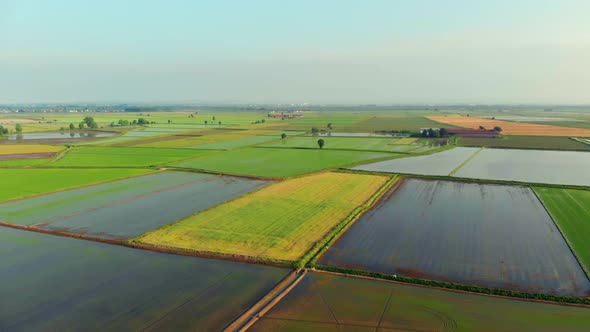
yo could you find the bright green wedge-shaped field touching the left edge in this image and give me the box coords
[0,168,151,201]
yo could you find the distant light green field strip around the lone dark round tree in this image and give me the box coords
[262,137,428,152]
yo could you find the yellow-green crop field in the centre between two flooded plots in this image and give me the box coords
[136,173,389,261]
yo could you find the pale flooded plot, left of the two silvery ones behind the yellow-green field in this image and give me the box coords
[352,148,479,175]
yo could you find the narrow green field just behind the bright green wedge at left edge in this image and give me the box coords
[52,147,212,167]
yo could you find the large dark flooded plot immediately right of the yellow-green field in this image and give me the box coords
[319,179,590,296]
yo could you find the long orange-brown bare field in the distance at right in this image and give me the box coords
[428,116,590,137]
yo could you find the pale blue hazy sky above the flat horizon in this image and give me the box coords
[0,0,590,105]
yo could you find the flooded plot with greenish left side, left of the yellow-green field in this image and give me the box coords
[0,172,269,239]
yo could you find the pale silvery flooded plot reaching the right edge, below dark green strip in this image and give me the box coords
[455,149,590,186]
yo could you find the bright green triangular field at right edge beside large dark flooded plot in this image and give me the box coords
[535,187,590,273]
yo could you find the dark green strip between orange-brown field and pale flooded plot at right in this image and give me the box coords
[457,136,590,151]
